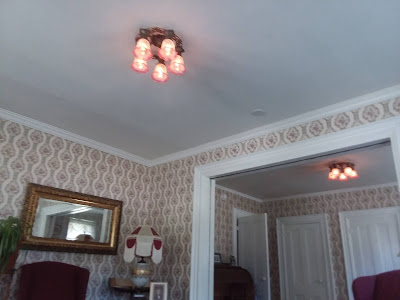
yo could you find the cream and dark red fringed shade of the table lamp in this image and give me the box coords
[124,225,162,264]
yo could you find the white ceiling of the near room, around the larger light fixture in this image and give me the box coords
[0,0,400,159]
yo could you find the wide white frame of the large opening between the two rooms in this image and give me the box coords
[190,117,400,300]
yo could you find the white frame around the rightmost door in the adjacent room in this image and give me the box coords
[339,206,400,300]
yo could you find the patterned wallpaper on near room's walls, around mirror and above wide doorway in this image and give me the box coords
[0,98,400,300]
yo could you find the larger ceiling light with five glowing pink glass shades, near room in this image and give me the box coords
[131,27,186,83]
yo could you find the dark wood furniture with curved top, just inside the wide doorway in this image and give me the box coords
[214,264,254,300]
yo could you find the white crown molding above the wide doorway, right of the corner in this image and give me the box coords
[150,85,400,166]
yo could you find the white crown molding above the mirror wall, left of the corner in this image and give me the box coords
[0,108,150,166]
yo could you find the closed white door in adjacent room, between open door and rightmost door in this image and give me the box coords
[277,214,336,300]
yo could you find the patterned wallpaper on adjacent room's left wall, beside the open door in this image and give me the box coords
[214,188,265,262]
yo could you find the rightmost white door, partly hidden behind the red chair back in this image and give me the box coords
[339,207,400,299]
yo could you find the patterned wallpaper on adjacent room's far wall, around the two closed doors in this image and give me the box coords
[265,185,400,300]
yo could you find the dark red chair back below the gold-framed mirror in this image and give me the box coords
[18,261,89,300]
